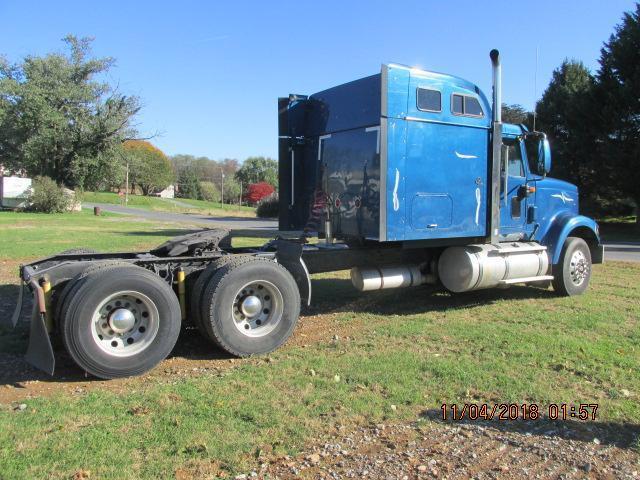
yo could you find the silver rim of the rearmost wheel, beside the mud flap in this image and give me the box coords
[91,290,160,357]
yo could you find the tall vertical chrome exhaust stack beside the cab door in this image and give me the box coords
[486,49,502,244]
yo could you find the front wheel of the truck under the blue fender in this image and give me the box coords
[553,237,592,296]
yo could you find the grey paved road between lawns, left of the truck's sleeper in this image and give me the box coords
[82,203,278,231]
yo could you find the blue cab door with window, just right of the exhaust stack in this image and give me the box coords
[500,138,528,240]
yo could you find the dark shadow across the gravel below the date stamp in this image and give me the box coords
[420,406,640,450]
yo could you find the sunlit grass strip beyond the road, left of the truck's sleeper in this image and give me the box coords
[82,192,256,217]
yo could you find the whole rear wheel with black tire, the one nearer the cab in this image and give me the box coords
[202,257,300,357]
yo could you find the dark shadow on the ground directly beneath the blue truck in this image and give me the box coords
[0,278,554,388]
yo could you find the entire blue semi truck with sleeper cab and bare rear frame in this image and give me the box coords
[13,50,603,378]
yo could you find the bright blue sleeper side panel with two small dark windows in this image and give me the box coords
[404,71,490,240]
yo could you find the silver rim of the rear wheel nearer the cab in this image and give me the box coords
[231,280,284,337]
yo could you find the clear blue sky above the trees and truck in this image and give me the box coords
[0,0,635,160]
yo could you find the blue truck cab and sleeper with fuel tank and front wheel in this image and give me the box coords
[279,51,603,294]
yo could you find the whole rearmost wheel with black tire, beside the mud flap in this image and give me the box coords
[60,265,181,379]
